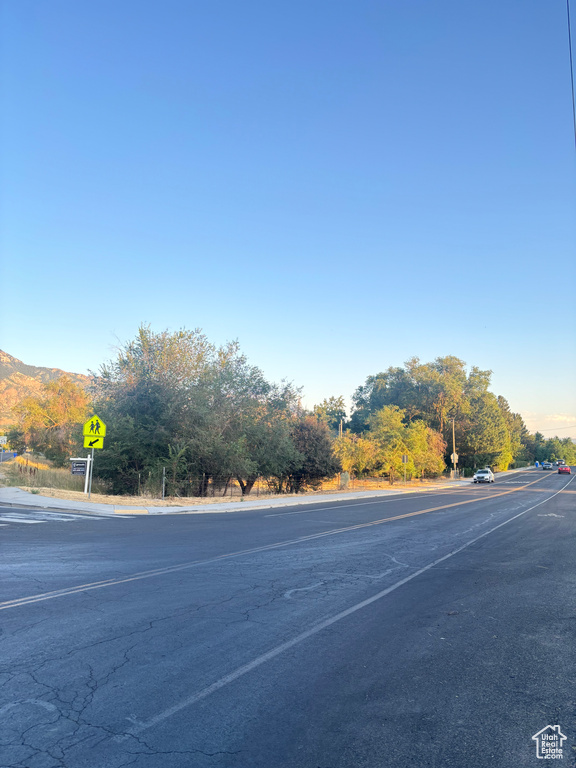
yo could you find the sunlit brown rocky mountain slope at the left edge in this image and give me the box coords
[0,349,91,433]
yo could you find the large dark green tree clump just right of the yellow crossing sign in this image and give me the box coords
[91,326,300,496]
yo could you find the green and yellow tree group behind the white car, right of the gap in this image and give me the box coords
[316,356,576,477]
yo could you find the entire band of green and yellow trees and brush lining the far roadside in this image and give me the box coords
[8,326,576,498]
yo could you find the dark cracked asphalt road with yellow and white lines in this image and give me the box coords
[0,471,576,768]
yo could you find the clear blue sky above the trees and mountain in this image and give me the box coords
[0,0,576,437]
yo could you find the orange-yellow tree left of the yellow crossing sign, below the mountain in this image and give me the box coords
[11,376,90,466]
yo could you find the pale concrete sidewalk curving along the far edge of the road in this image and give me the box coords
[0,467,533,516]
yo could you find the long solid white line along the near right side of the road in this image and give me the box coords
[124,476,576,741]
